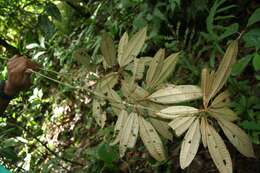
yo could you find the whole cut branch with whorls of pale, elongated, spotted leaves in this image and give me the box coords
[88,27,254,173]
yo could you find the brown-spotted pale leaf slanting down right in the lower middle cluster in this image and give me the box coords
[139,116,166,161]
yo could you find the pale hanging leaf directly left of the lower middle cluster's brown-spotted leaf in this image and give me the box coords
[119,112,139,157]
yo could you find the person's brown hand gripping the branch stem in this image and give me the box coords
[4,55,39,96]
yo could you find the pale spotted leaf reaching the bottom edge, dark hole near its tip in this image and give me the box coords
[207,125,232,173]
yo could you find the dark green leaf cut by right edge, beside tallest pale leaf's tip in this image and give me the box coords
[243,28,260,49]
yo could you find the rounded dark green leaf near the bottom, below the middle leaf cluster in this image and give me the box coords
[97,143,119,164]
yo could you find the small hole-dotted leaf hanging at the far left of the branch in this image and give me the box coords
[92,99,107,128]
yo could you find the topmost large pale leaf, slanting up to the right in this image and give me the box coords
[118,27,147,67]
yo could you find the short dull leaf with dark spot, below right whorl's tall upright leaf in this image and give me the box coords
[210,91,230,108]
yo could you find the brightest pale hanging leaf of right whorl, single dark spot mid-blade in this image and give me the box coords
[180,119,201,169]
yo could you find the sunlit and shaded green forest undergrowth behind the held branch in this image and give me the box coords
[0,0,260,173]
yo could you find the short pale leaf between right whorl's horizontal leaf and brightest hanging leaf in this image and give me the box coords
[168,116,196,136]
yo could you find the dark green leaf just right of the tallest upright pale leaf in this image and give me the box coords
[231,55,252,76]
